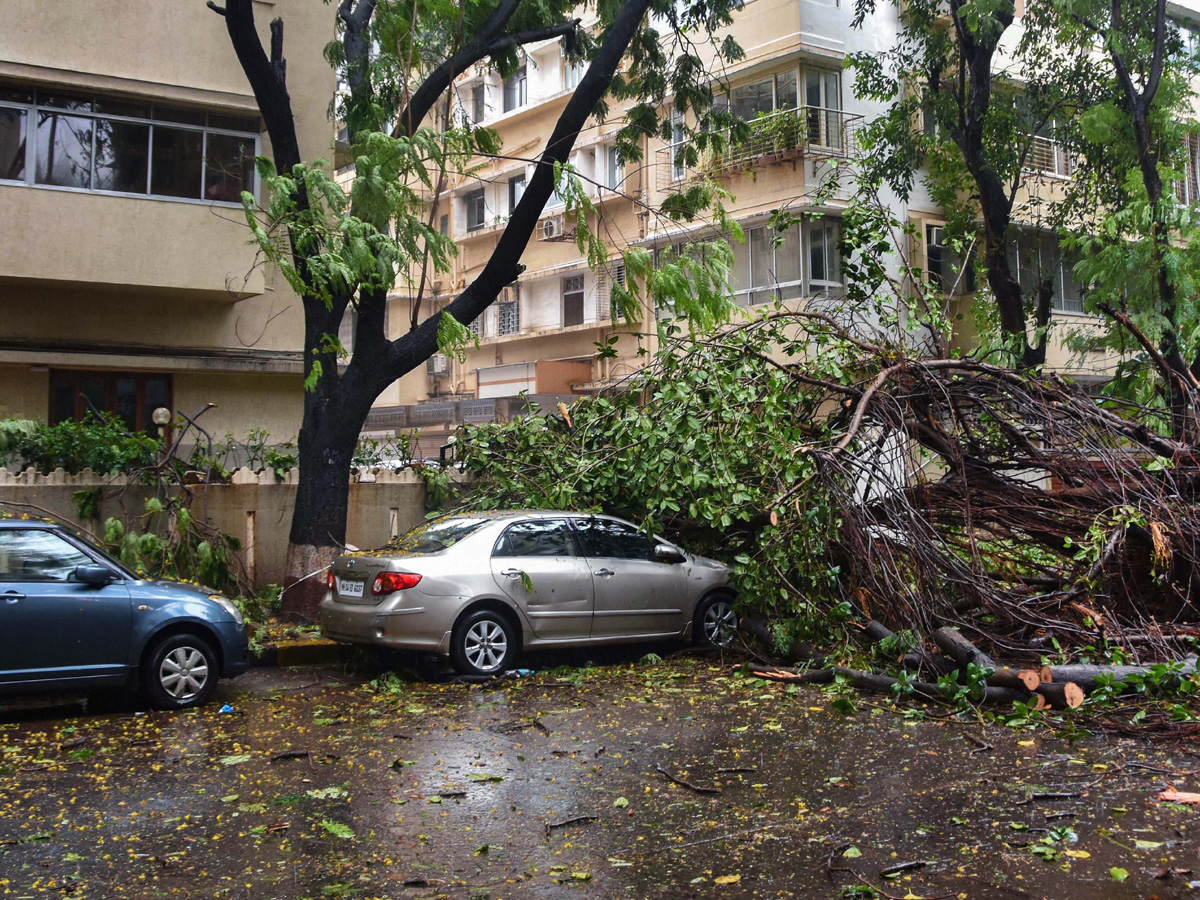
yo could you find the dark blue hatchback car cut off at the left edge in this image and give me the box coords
[0,512,250,709]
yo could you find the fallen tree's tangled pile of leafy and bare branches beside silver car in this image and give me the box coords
[464,307,1200,696]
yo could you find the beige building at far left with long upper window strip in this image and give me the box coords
[0,0,335,440]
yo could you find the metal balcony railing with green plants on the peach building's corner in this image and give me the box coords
[655,107,864,191]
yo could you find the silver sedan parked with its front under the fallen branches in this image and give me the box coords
[320,511,737,674]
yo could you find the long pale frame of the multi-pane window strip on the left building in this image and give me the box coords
[0,85,263,209]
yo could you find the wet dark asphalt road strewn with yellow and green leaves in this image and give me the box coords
[0,652,1200,900]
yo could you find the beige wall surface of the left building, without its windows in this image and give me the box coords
[0,0,336,439]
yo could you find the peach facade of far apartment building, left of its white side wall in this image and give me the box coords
[367,0,899,455]
